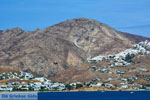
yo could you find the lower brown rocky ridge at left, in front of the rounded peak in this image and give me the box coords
[0,28,86,77]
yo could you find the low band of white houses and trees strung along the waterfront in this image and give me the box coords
[0,72,150,91]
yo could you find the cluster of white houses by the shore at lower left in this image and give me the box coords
[0,72,65,91]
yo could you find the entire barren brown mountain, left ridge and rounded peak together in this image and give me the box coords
[0,18,150,81]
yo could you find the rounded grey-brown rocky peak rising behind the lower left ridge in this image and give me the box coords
[44,18,148,56]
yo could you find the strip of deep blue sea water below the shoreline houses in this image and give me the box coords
[38,91,150,100]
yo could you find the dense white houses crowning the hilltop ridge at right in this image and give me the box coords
[88,40,150,66]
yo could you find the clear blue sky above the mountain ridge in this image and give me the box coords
[0,0,150,37]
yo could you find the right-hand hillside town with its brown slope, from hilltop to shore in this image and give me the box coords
[85,40,150,90]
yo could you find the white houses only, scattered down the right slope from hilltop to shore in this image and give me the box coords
[88,41,150,90]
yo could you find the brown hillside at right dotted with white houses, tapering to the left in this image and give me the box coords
[52,41,150,88]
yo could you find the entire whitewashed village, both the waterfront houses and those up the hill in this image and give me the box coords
[0,41,150,91]
